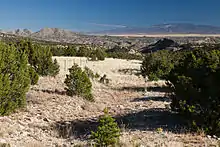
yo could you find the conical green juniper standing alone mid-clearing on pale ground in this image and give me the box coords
[64,64,94,101]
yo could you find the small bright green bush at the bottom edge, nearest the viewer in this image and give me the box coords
[90,109,120,147]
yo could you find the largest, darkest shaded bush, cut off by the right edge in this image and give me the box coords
[167,49,220,135]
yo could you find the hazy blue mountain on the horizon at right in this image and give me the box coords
[92,23,220,35]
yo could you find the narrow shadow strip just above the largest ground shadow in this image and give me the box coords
[131,96,171,102]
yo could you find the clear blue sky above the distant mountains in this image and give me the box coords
[0,0,220,32]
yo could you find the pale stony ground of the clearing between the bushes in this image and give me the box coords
[0,59,220,147]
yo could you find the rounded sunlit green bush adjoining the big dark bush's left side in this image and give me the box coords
[141,50,174,81]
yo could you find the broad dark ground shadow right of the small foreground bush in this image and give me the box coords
[116,108,187,133]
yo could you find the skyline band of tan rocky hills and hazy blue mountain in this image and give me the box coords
[0,23,220,39]
